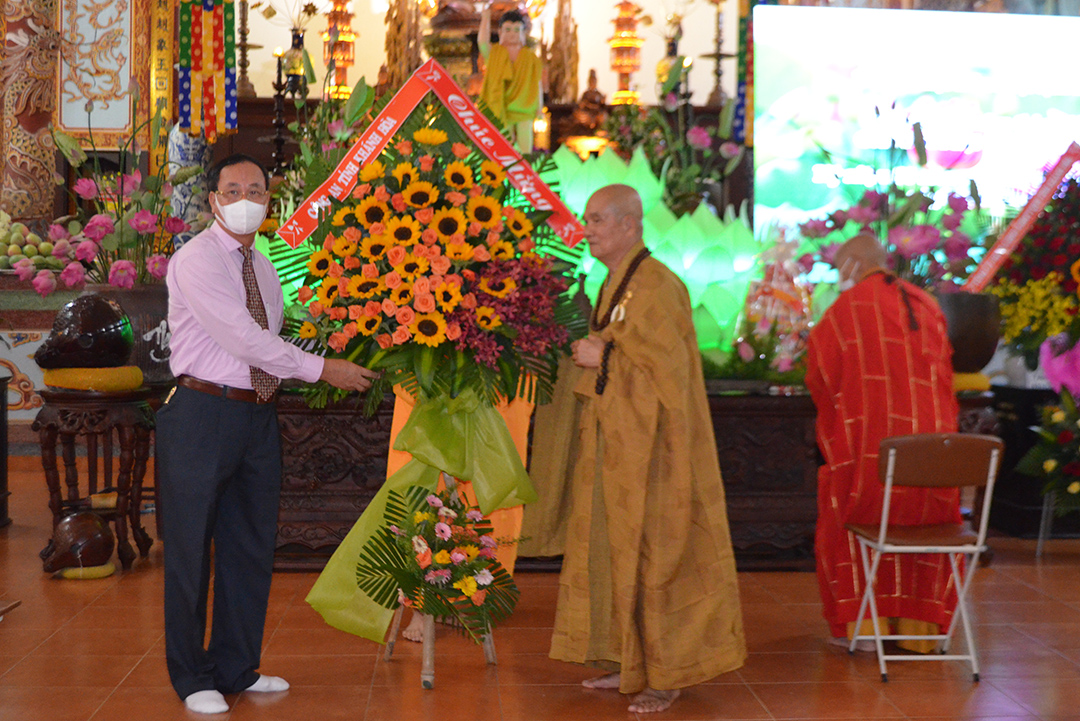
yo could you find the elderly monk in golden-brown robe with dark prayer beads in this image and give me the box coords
[551,186,746,713]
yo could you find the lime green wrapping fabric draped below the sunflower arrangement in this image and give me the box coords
[307,391,537,643]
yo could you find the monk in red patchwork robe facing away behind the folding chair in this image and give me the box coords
[806,234,960,651]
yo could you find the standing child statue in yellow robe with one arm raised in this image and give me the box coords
[476,5,543,153]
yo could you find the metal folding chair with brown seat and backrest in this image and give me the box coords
[847,433,1004,682]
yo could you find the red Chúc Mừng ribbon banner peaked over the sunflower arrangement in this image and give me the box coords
[278,59,584,248]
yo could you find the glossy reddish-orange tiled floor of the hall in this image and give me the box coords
[0,458,1080,721]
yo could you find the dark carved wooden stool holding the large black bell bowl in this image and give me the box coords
[30,386,156,570]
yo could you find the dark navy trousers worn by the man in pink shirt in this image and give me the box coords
[156,387,281,698]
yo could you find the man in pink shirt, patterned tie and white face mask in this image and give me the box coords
[157,155,375,713]
